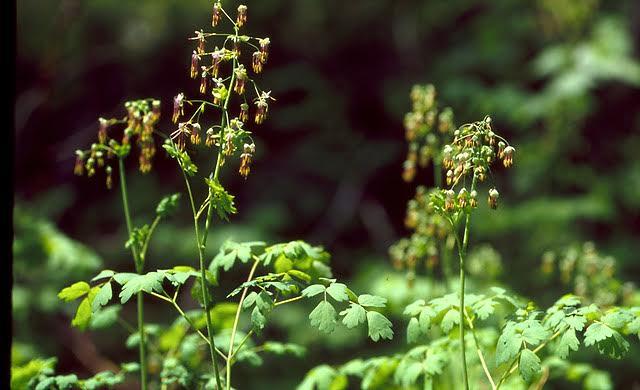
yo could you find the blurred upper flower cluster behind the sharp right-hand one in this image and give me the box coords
[402,84,454,182]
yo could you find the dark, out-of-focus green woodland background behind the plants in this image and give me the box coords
[12,0,640,388]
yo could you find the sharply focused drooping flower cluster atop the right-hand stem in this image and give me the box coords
[431,116,515,214]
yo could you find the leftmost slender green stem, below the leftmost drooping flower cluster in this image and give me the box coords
[118,157,147,390]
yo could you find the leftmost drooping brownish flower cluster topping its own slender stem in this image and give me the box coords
[73,99,160,188]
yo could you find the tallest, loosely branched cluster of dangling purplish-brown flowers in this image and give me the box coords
[170,1,275,178]
